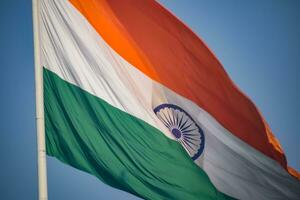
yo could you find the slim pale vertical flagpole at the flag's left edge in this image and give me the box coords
[32,0,48,200]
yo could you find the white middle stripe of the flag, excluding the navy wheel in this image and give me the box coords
[40,0,300,199]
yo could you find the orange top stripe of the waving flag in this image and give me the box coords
[71,0,298,178]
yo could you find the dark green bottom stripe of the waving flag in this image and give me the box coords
[44,68,233,200]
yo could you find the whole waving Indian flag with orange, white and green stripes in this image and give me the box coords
[38,0,300,200]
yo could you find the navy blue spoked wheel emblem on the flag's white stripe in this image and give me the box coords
[154,104,205,160]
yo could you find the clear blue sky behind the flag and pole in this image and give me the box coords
[0,0,300,200]
